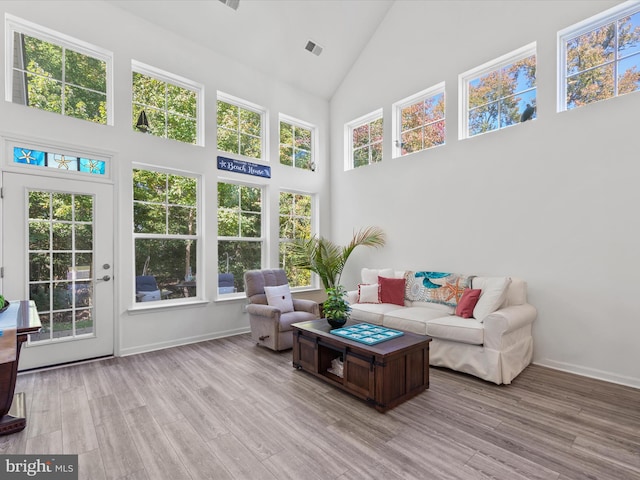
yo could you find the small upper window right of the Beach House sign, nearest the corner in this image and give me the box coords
[280,114,317,171]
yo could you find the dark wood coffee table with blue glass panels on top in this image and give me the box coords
[292,319,431,412]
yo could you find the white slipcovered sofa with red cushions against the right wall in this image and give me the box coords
[347,268,537,384]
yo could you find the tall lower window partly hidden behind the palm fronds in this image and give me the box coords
[279,192,313,287]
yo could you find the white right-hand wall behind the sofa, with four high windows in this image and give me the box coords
[331,0,640,387]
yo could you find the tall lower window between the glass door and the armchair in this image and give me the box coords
[133,169,199,302]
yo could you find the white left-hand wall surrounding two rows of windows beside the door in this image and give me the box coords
[0,1,329,354]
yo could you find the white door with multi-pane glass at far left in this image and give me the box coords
[2,172,114,370]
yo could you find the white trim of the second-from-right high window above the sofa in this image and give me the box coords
[458,42,538,140]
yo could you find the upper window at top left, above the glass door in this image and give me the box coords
[5,14,113,125]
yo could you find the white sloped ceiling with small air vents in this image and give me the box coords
[106,0,395,99]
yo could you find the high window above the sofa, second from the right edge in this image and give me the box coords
[458,42,537,139]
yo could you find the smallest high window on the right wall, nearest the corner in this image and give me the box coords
[345,108,384,170]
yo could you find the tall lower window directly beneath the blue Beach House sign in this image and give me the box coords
[218,182,264,293]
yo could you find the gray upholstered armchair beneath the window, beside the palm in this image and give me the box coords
[244,270,320,351]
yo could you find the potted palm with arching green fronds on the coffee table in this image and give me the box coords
[293,227,386,327]
